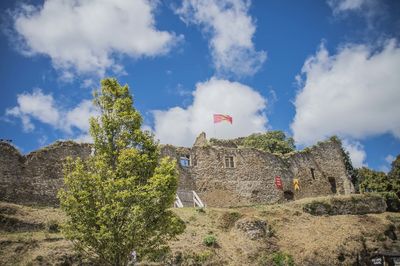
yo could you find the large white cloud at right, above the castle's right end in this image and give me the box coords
[291,40,400,144]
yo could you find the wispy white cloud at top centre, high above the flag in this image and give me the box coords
[176,0,267,76]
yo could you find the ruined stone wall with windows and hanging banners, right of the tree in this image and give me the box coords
[162,138,351,207]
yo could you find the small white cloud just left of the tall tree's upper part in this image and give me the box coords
[6,89,98,135]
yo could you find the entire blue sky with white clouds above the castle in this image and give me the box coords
[0,0,400,171]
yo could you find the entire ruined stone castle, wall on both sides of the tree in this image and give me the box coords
[0,133,354,207]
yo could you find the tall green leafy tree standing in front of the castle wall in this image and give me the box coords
[59,79,184,265]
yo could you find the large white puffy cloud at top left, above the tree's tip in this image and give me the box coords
[13,0,181,77]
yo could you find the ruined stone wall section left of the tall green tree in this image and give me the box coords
[0,141,90,206]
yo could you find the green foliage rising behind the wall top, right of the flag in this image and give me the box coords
[243,130,296,154]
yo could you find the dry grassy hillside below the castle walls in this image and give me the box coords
[0,194,400,265]
